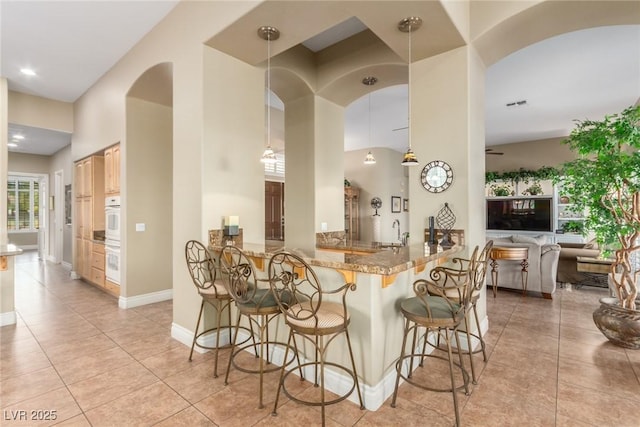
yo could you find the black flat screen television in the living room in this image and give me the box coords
[487,198,553,231]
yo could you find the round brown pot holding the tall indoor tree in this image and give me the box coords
[593,298,640,350]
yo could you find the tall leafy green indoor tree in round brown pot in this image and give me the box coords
[561,106,640,348]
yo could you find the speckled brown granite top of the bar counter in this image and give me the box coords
[210,242,464,275]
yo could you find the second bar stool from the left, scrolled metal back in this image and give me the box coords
[220,246,291,409]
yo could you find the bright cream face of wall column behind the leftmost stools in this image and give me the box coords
[204,48,265,244]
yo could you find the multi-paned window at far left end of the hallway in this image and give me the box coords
[7,175,40,231]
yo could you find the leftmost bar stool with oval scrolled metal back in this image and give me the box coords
[184,240,233,378]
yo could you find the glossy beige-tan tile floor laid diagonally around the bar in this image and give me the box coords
[0,253,640,426]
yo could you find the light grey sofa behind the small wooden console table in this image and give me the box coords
[487,235,560,299]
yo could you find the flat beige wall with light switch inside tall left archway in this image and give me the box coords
[121,97,173,297]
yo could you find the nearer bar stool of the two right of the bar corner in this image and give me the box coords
[391,258,477,426]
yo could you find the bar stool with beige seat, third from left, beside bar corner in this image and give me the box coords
[269,252,364,426]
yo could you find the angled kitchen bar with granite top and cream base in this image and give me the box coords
[209,234,464,410]
